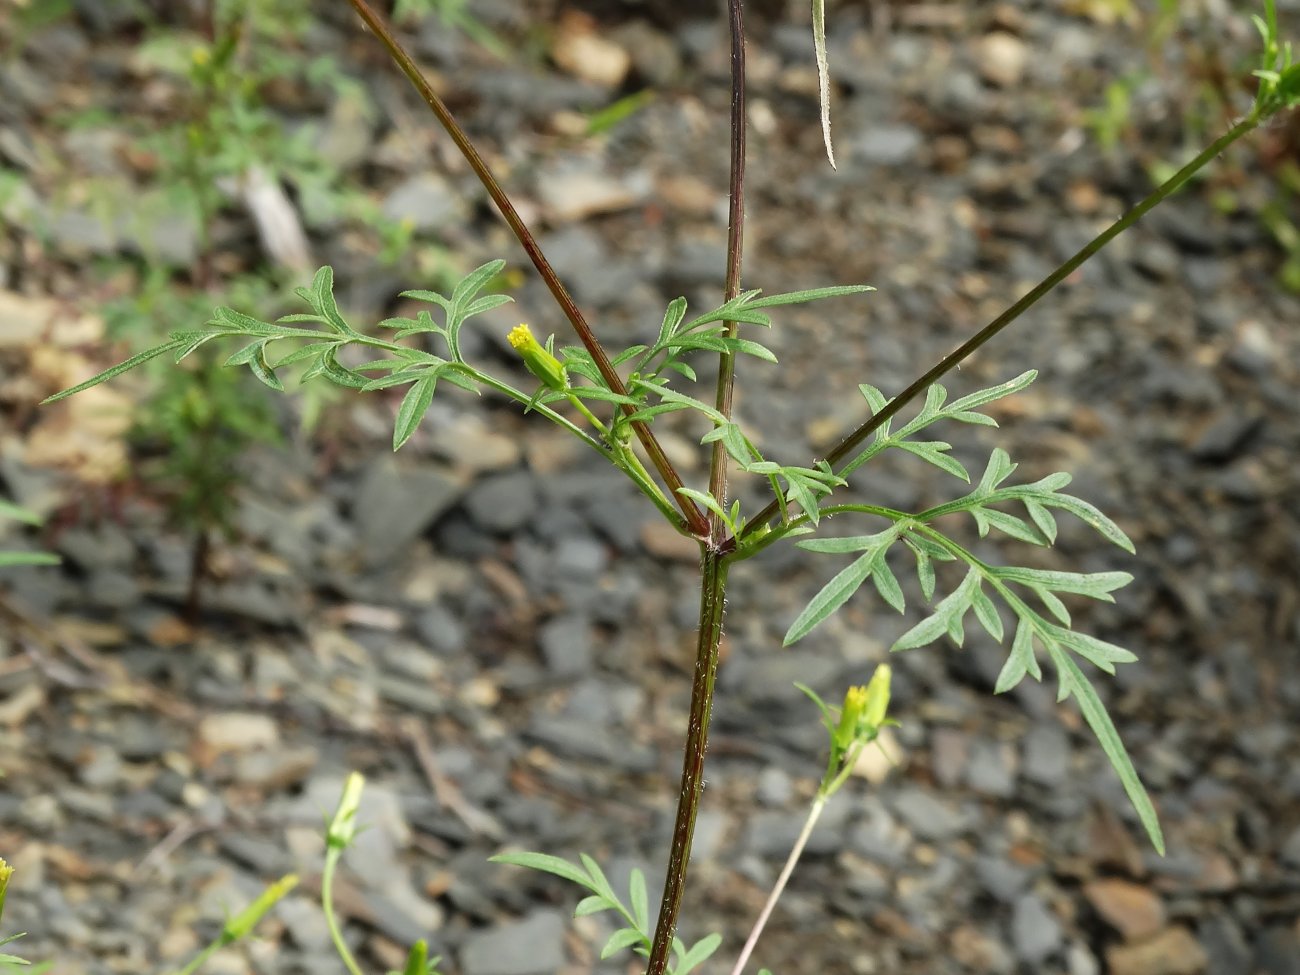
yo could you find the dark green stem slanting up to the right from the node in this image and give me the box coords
[724,111,1264,551]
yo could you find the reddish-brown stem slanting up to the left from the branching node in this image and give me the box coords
[348,0,709,538]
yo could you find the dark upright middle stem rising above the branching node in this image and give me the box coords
[709,0,745,540]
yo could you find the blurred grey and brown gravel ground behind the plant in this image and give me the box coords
[0,0,1300,975]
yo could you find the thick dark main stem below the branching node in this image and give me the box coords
[646,546,728,975]
